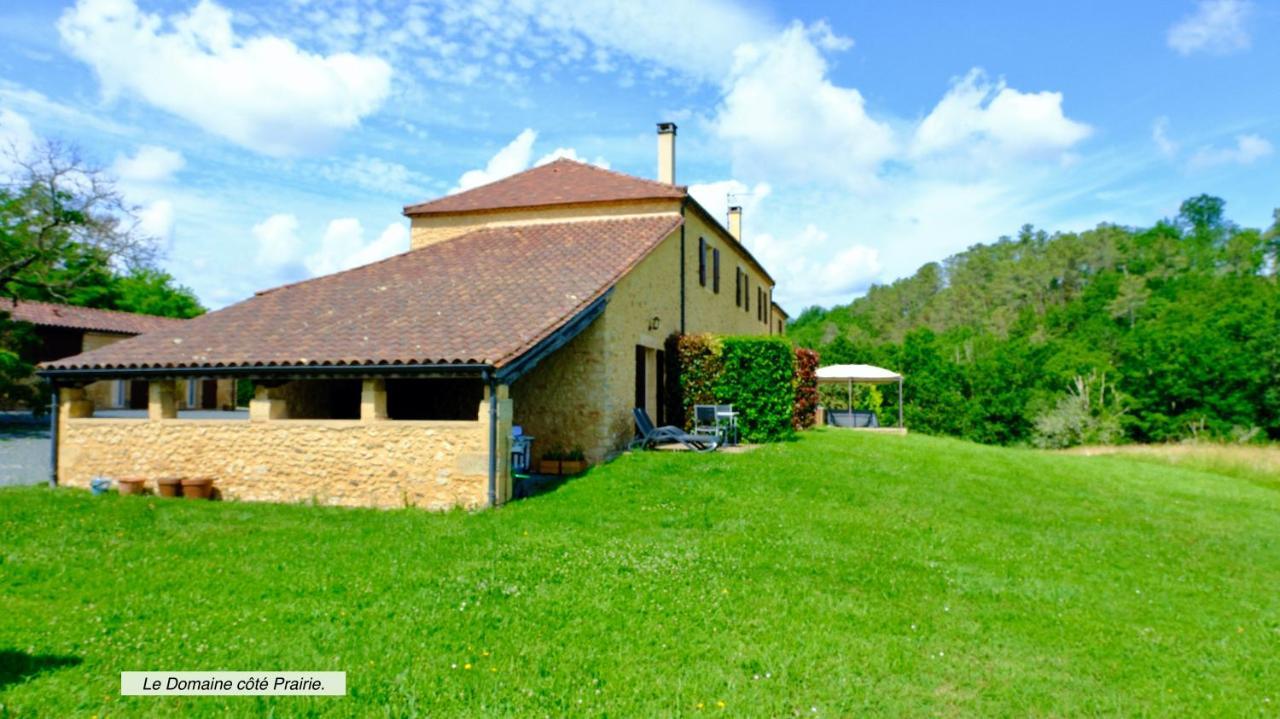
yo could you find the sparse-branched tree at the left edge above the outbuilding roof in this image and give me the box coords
[0,141,156,301]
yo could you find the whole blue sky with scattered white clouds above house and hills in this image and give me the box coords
[0,0,1280,311]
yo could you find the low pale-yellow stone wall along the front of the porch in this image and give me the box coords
[58,412,489,509]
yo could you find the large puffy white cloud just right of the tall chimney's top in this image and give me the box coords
[712,23,896,186]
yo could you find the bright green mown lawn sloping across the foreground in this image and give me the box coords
[0,431,1280,716]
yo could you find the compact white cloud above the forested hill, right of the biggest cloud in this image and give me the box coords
[910,68,1092,161]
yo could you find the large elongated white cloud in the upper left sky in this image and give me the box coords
[58,0,392,155]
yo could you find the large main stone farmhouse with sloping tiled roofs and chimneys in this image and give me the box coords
[42,123,785,509]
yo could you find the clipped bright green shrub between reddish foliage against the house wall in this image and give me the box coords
[716,336,796,441]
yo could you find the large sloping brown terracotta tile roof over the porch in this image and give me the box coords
[42,214,681,370]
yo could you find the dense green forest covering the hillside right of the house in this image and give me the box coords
[788,194,1280,446]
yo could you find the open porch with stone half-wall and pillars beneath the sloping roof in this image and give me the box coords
[47,367,512,509]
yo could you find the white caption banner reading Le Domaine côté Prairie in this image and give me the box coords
[120,672,347,696]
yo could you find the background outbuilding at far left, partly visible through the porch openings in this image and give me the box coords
[0,299,236,409]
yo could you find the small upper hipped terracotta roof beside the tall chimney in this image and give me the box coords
[404,159,687,216]
